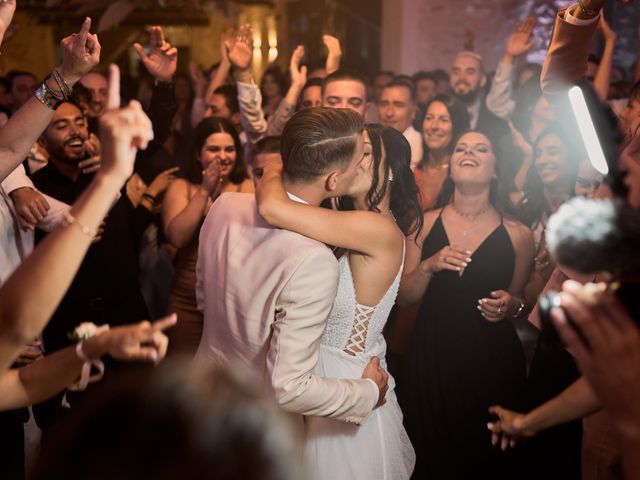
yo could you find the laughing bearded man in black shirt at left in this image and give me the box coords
[33,102,152,440]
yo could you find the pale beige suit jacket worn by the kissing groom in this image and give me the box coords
[196,193,379,424]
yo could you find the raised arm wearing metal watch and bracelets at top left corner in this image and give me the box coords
[0,16,100,181]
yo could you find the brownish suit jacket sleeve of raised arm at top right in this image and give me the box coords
[540,9,598,105]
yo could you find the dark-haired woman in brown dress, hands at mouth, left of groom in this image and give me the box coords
[162,117,253,355]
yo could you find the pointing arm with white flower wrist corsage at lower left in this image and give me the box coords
[0,315,176,411]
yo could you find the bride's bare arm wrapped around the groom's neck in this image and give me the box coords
[256,162,403,256]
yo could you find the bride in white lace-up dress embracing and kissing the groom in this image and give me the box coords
[256,125,422,480]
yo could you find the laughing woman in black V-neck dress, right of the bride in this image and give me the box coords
[398,132,534,479]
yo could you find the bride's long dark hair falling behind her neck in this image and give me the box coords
[338,124,424,236]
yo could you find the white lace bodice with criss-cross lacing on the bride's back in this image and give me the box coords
[321,249,404,356]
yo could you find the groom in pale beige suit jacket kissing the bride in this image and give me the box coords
[196,108,388,424]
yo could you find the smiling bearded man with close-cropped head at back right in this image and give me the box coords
[450,51,509,143]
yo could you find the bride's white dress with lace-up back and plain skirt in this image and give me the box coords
[305,254,415,480]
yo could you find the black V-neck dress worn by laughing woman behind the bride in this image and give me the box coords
[403,217,526,479]
